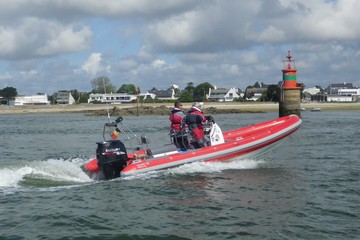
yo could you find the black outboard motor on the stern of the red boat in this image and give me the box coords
[96,140,128,180]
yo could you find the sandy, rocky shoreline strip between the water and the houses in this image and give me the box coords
[0,102,360,115]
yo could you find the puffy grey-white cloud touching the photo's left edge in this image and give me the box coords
[0,18,92,60]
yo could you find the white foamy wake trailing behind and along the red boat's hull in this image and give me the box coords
[0,157,263,193]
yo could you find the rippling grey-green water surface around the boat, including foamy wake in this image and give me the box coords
[0,111,360,240]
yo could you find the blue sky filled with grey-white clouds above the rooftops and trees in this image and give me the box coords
[0,0,360,94]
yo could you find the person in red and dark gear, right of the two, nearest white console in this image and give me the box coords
[183,102,207,148]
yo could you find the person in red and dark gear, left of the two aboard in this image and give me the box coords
[169,102,186,148]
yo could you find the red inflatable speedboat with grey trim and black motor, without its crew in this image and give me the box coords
[85,115,302,179]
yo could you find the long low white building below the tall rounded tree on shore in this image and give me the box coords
[88,93,137,104]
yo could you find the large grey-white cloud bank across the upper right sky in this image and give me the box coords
[148,0,360,52]
